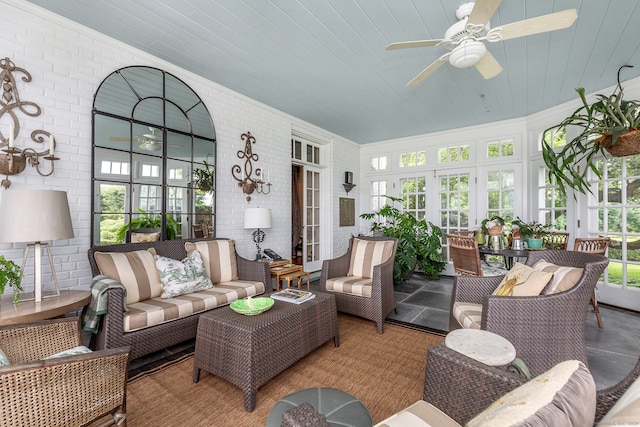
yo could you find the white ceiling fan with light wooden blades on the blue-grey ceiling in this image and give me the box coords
[386,0,578,86]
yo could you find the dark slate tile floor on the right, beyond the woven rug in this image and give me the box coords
[389,273,640,389]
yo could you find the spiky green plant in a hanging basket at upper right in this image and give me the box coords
[542,65,640,195]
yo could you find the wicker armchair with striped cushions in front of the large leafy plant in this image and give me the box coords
[320,236,398,334]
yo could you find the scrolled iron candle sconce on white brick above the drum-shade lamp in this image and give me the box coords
[0,58,60,189]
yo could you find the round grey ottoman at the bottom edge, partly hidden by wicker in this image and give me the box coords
[267,387,373,427]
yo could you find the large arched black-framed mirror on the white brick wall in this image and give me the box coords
[91,66,216,245]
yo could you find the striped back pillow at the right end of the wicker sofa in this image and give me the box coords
[184,240,238,285]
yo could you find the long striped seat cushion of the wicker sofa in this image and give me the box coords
[124,281,264,332]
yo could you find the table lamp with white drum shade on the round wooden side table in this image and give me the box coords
[0,190,74,302]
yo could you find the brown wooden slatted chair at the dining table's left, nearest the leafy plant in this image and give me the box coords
[447,233,507,276]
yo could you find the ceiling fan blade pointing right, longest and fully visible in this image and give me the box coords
[487,9,578,41]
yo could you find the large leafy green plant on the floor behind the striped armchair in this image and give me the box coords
[360,196,446,285]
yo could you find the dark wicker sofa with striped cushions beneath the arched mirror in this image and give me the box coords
[88,238,271,360]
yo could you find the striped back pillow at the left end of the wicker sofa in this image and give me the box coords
[94,251,162,305]
